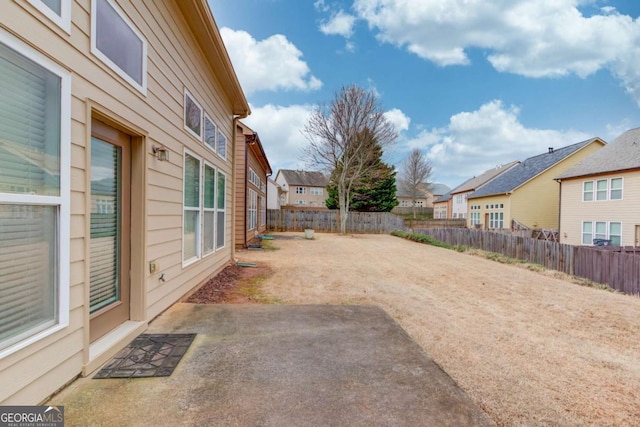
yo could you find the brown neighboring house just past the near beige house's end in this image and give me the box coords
[234,121,272,248]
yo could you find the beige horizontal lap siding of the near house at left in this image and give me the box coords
[0,0,248,404]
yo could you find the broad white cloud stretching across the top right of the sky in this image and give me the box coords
[354,0,640,102]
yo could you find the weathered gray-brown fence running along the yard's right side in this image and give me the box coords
[416,228,640,295]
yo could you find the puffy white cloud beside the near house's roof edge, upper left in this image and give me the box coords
[220,27,322,95]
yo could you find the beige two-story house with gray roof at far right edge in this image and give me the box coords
[557,128,640,246]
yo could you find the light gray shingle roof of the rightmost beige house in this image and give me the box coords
[557,128,640,179]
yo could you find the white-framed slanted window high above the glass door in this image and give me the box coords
[91,0,147,94]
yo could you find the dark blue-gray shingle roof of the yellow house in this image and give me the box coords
[468,138,602,199]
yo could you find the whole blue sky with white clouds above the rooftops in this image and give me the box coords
[209,0,640,187]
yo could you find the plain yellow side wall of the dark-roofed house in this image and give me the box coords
[511,143,602,229]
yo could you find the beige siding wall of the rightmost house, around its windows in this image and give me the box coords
[560,171,640,246]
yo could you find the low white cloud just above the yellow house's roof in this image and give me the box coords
[405,100,597,187]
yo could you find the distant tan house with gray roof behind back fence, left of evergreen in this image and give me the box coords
[275,169,329,208]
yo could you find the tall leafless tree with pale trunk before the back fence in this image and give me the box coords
[302,85,398,234]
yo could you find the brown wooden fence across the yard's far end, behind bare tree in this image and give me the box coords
[267,209,404,234]
